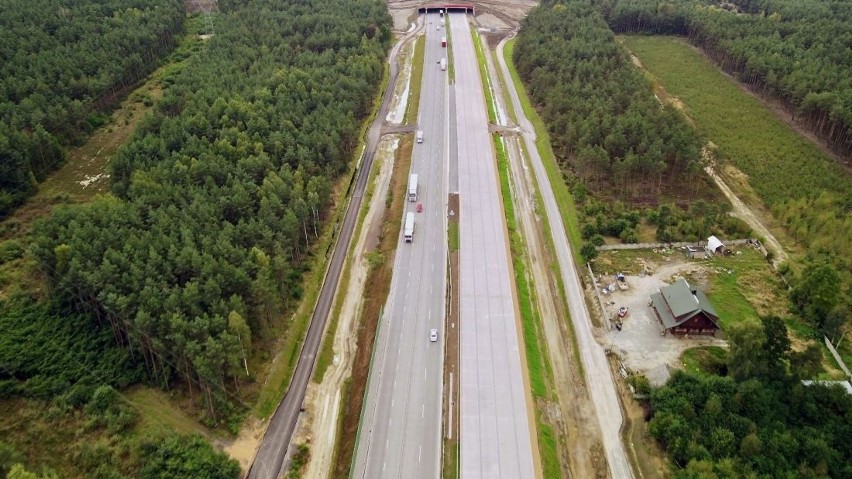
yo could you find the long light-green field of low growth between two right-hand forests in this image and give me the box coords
[624,36,852,266]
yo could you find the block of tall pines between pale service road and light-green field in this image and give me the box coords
[514,1,701,201]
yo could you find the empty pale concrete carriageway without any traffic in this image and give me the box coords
[450,13,535,479]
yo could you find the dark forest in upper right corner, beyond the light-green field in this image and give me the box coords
[593,0,852,161]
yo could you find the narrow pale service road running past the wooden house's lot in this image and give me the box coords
[497,35,633,479]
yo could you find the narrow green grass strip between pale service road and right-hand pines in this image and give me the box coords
[503,40,583,264]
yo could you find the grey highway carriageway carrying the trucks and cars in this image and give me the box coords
[353,14,448,479]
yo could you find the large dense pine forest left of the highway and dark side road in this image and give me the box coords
[31,0,391,422]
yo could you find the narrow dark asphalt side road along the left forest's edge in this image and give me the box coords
[248,17,417,479]
